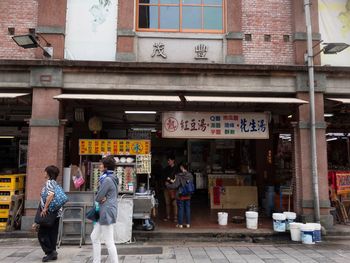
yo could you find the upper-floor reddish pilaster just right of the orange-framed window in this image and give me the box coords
[225,0,244,64]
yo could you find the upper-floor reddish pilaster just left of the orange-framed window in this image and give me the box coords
[116,0,137,61]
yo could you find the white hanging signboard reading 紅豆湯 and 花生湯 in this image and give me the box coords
[162,111,269,139]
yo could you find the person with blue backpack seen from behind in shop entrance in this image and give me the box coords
[166,163,194,228]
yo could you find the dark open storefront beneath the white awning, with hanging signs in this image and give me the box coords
[48,93,305,231]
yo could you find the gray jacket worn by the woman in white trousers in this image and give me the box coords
[95,176,118,225]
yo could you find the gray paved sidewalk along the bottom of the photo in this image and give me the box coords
[0,239,350,263]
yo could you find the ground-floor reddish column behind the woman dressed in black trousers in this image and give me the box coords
[22,88,64,230]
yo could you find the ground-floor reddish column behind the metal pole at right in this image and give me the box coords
[294,92,333,227]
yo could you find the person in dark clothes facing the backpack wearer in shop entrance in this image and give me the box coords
[162,155,180,222]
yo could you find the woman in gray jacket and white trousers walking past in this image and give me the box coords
[91,155,118,263]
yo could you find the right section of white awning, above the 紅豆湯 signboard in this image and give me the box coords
[185,96,309,104]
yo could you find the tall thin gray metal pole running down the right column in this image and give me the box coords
[304,0,320,223]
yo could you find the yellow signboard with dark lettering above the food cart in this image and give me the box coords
[79,139,151,155]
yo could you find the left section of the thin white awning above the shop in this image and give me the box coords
[54,94,181,102]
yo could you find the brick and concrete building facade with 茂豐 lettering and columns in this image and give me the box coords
[0,0,350,229]
